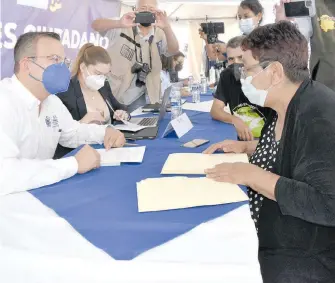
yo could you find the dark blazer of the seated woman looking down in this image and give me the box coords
[54,76,126,159]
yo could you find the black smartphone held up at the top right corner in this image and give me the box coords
[284,0,316,18]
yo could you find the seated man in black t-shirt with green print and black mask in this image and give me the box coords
[211,36,268,141]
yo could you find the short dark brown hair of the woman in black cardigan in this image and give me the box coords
[242,21,309,83]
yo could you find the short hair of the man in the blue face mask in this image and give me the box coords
[14,31,60,73]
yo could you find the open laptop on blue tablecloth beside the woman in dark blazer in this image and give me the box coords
[122,87,172,140]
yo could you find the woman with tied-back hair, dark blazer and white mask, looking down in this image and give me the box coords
[54,43,130,159]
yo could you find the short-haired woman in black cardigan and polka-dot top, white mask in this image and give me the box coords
[206,21,335,283]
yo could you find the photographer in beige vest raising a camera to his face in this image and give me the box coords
[92,0,179,112]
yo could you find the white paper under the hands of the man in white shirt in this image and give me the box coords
[98,146,145,166]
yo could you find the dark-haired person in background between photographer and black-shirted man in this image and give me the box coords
[161,51,189,99]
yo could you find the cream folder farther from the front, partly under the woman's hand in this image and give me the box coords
[161,153,249,174]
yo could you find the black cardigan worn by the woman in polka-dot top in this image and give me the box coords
[258,80,335,283]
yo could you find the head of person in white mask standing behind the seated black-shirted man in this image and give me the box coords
[237,0,264,35]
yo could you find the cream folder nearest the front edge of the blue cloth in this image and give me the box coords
[137,177,248,212]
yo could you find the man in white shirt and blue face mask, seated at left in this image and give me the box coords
[0,32,125,195]
